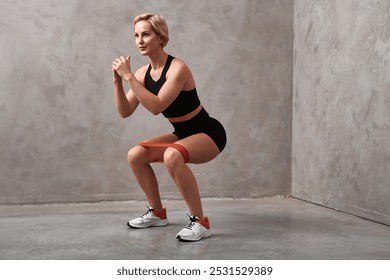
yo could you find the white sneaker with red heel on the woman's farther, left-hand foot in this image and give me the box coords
[127,206,169,228]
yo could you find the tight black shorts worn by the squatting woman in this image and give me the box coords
[172,108,226,152]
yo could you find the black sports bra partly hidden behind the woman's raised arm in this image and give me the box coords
[145,55,200,118]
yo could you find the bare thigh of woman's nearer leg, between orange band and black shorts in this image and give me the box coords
[175,133,220,163]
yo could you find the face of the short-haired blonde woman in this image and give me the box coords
[134,20,161,55]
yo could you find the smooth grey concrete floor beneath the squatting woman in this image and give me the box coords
[0,198,390,260]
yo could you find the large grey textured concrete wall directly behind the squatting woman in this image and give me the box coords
[0,0,292,203]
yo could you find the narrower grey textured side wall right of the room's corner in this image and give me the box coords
[292,0,390,224]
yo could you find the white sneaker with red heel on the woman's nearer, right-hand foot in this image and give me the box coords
[176,216,212,241]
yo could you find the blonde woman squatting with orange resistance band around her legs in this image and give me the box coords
[112,14,226,241]
